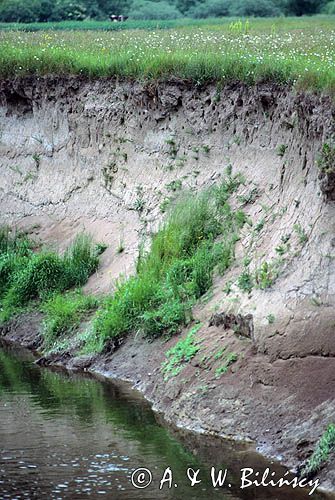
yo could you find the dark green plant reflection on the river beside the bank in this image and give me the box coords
[0,344,205,471]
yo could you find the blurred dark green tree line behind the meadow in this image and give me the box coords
[0,0,335,23]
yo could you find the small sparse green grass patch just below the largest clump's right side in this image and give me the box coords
[162,324,202,380]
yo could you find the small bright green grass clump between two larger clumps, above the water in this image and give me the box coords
[42,290,99,349]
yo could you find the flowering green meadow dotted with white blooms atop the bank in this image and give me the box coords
[0,16,335,93]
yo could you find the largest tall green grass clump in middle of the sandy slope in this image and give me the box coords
[85,171,242,350]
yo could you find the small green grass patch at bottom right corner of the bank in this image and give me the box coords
[299,424,335,478]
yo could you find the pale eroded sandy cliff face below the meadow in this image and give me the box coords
[0,77,335,488]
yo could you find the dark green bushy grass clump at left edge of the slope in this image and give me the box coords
[0,235,99,321]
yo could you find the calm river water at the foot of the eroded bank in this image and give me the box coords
[0,344,330,500]
